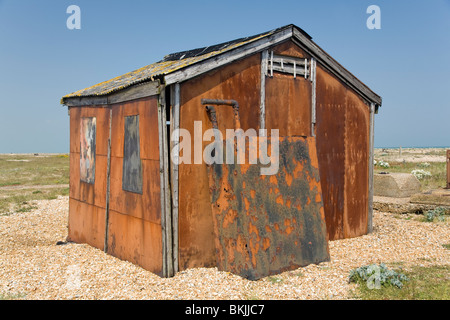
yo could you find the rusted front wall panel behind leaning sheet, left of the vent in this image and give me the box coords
[178,54,261,270]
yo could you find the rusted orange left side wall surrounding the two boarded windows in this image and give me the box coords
[68,97,162,274]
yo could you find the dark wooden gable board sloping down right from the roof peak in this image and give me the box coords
[292,28,381,105]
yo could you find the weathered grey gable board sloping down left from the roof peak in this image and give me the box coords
[165,28,292,85]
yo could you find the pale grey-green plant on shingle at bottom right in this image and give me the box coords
[349,263,408,289]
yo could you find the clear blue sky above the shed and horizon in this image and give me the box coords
[0,0,450,153]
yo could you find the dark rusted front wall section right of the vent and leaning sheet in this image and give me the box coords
[316,64,369,240]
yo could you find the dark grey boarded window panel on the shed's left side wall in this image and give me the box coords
[122,115,142,194]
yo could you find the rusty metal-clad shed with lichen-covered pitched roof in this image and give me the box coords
[61,25,381,278]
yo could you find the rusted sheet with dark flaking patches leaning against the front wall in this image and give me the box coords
[208,137,329,280]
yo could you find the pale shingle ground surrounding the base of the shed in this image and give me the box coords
[0,197,450,300]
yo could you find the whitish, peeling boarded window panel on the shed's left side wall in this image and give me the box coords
[80,117,97,183]
